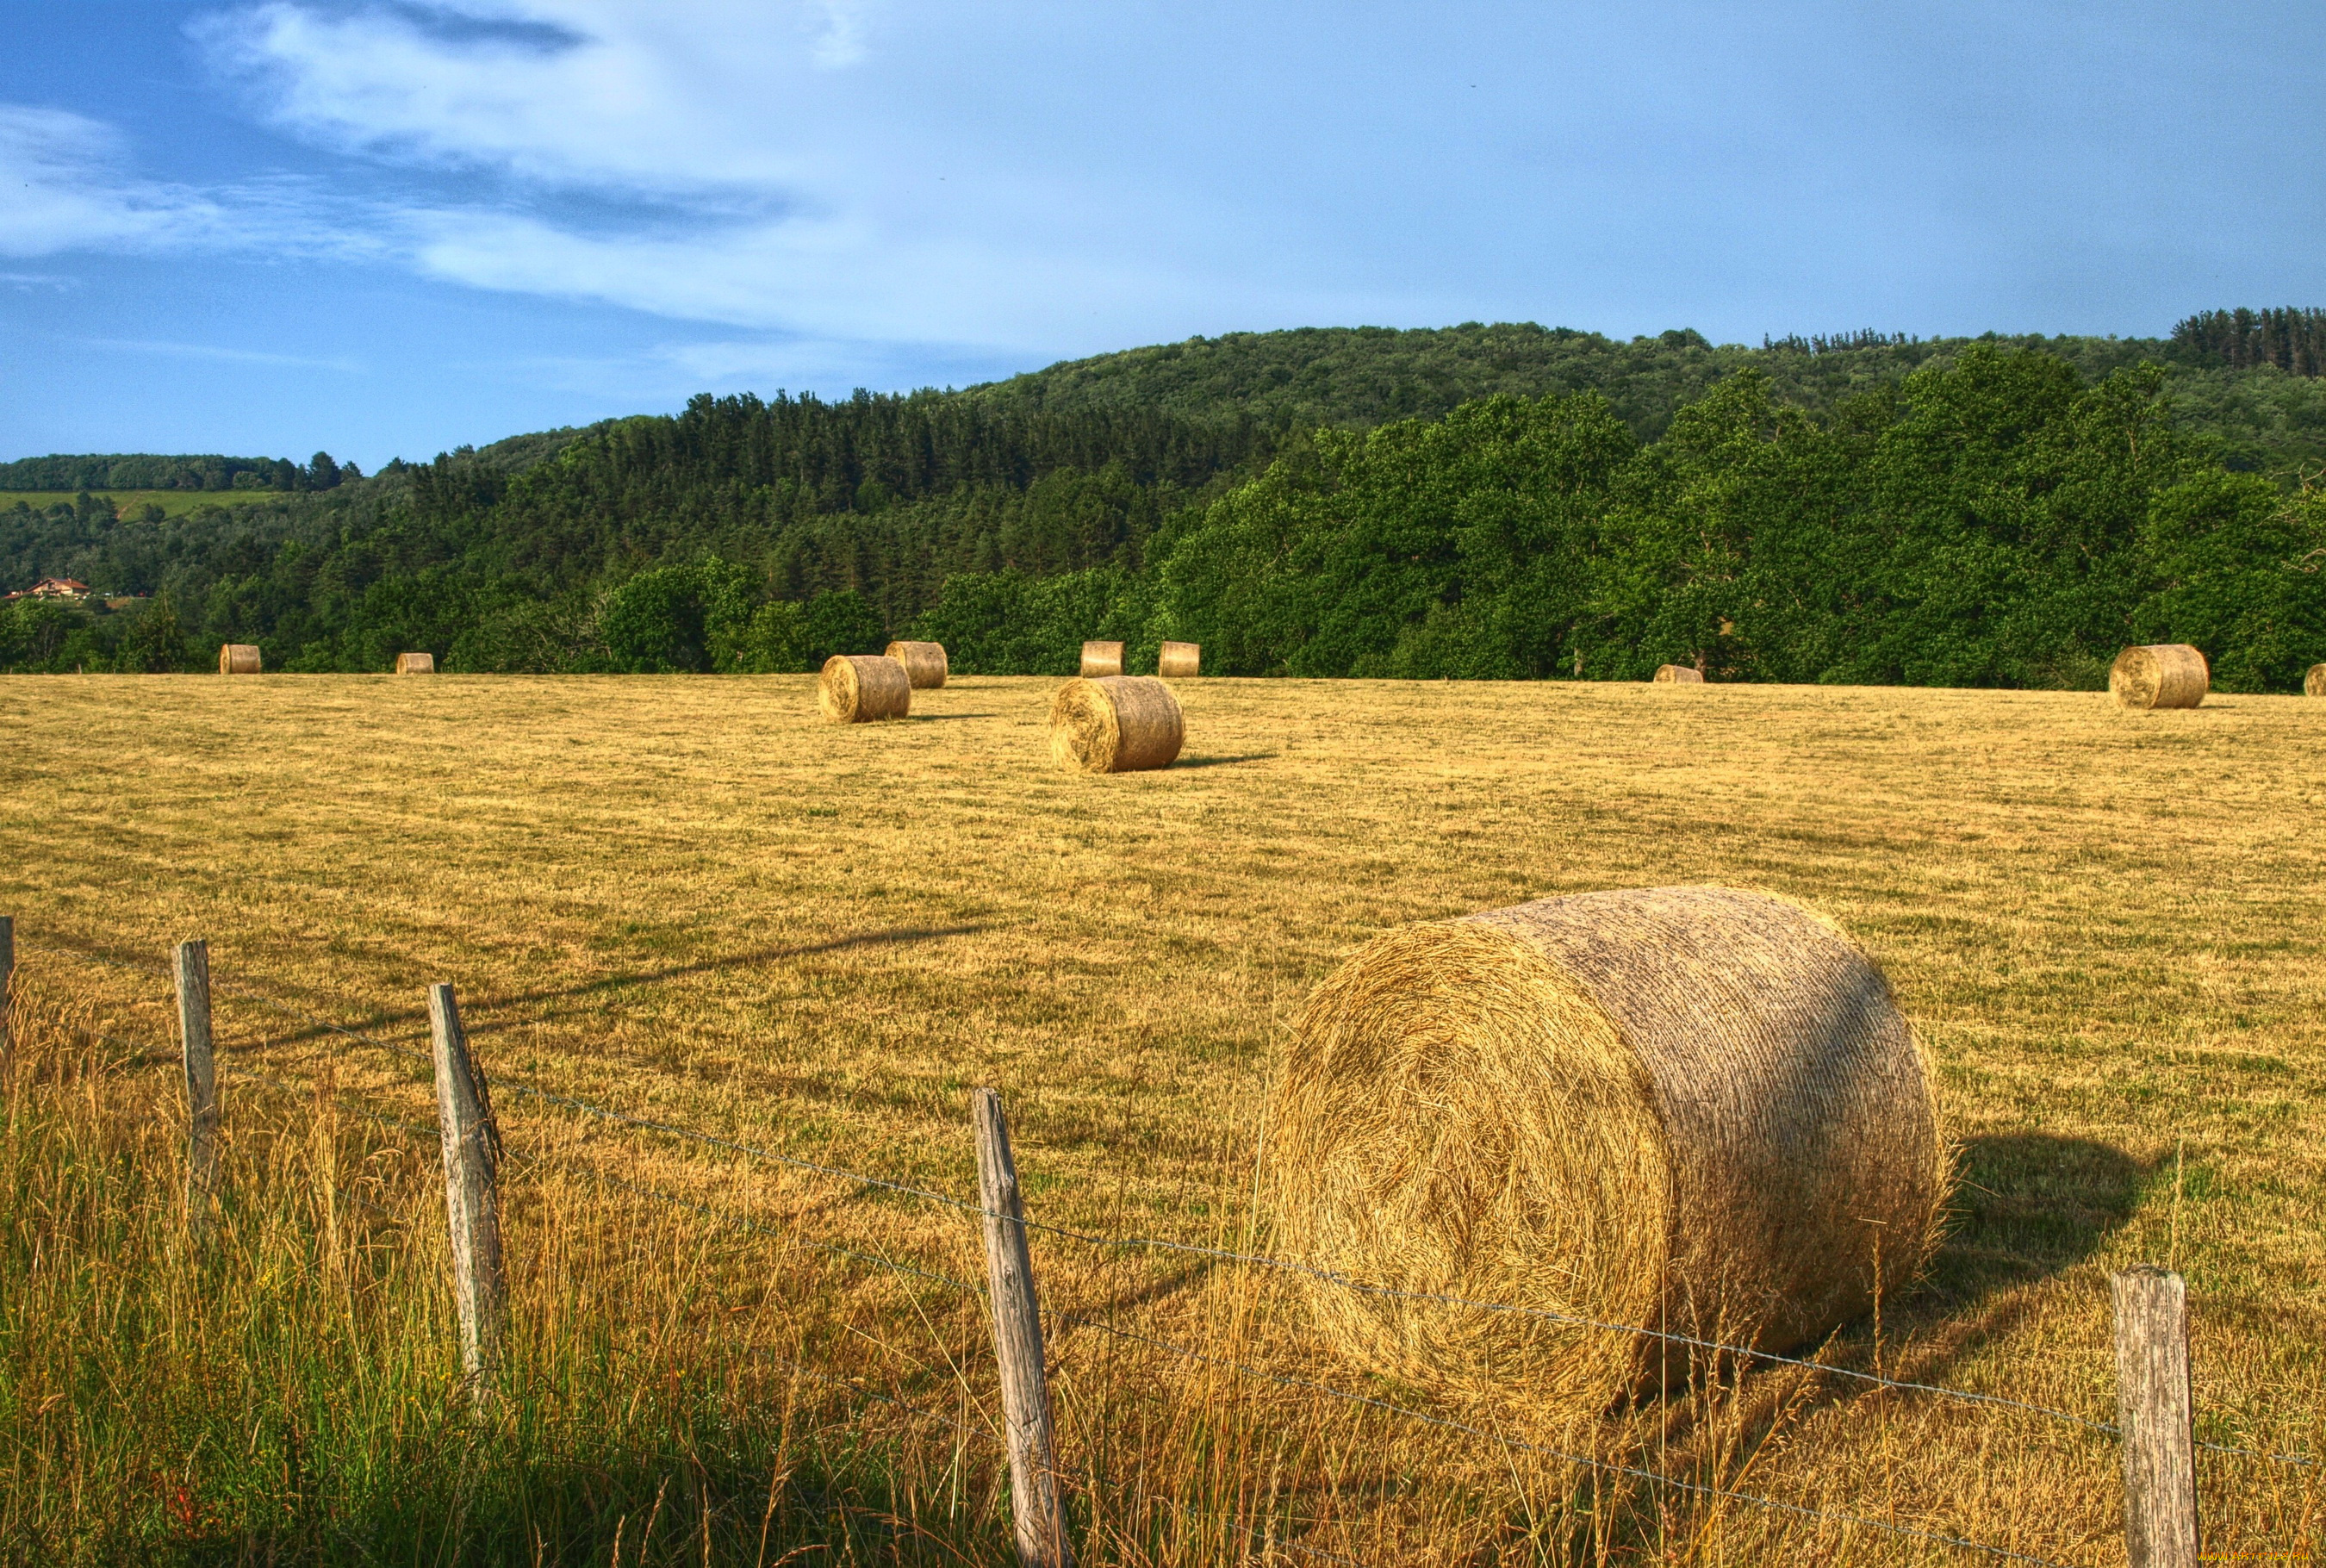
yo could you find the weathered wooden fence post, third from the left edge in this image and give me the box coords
[428,986,507,1405]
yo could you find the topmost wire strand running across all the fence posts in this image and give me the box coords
[19,944,2317,1465]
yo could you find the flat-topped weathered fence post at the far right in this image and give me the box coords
[2110,1263,2196,1568]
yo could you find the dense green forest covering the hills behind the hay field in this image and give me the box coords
[0,312,2326,688]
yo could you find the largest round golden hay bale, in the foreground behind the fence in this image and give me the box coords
[1268,887,1947,1409]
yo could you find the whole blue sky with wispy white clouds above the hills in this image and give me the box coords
[0,0,2326,465]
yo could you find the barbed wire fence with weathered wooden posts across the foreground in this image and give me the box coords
[0,917,2319,1568]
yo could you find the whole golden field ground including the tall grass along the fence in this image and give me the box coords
[0,677,2326,1564]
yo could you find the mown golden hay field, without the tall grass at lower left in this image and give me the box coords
[0,675,2326,1564]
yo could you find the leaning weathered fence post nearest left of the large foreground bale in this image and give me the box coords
[970,1089,1074,1568]
